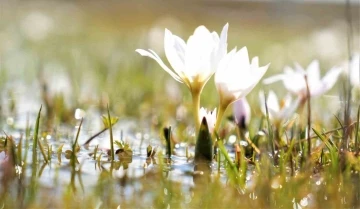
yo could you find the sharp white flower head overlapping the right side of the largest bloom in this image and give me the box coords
[215,47,269,106]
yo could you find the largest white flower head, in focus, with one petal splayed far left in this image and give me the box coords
[136,24,228,92]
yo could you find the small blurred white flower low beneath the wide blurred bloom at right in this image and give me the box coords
[259,90,300,122]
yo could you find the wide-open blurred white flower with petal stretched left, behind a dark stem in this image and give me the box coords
[263,60,341,98]
